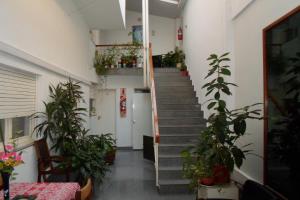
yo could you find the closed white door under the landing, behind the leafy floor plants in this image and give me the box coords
[91,90,116,138]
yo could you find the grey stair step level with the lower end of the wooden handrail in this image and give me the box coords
[160,134,199,144]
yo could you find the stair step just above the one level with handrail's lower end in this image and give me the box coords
[159,124,206,135]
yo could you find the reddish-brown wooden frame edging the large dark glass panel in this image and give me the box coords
[263,5,300,184]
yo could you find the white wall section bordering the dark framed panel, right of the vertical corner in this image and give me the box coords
[233,0,300,182]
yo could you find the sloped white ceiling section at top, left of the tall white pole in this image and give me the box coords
[73,0,124,30]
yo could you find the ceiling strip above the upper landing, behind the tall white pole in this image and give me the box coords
[126,0,182,18]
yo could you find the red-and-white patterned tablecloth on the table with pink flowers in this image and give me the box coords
[0,183,80,200]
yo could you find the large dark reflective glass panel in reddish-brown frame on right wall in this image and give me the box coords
[264,8,300,200]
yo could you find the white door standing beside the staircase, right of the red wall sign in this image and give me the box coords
[132,91,152,149]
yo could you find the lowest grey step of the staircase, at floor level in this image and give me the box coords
[159,179,192,194]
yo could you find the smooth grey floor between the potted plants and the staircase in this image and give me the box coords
[93,150,195,200]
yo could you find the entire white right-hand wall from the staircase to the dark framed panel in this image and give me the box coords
[182,0,300,182]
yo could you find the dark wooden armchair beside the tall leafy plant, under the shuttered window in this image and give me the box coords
[34,138,71,182]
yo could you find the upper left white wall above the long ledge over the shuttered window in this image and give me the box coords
[0,0,96,83]
